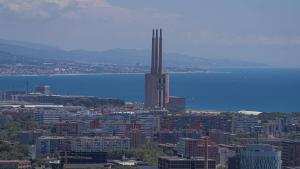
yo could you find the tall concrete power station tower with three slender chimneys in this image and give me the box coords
[144,29,169,109]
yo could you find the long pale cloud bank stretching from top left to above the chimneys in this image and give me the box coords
[0,0,180,27]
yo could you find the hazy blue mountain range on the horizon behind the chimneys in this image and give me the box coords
[0,39,268,68]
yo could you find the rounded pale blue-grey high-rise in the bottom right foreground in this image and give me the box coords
[240,144,281,169]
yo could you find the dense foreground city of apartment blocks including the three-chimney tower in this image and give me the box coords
[0,29,300,169]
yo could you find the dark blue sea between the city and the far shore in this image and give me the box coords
[0,69,300,112]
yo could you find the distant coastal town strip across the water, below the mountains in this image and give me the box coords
[0,61,208,76]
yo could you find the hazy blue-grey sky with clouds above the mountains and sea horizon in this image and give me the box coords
[0,0,300,67]
